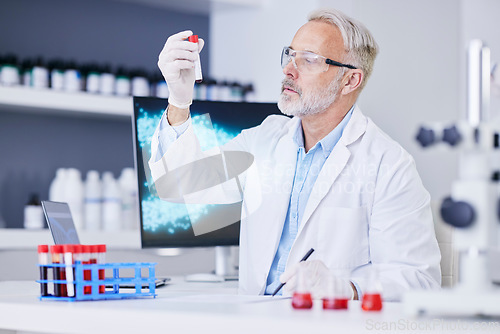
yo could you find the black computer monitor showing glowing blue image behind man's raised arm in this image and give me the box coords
[133,97,280,258]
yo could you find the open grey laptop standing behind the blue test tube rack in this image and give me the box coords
[42,201,170,289]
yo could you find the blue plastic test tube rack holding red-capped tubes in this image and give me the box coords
[36,261,157,301]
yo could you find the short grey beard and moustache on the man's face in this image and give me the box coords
[278,76,342,117]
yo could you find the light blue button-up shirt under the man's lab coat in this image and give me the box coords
[265,106,354,294]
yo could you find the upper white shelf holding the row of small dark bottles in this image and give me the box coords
[0,86,133,119]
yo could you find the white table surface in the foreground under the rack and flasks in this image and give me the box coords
[0,278,500,334]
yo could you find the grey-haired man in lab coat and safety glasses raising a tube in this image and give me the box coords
[149,10,440,300]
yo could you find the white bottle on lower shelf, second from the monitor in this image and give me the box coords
[102,172,122,231]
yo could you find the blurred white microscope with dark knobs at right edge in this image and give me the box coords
[403,40,500,316]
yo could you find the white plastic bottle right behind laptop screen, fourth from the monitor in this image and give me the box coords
[64,168,84,231]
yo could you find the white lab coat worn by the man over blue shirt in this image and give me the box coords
[149,107,441,300]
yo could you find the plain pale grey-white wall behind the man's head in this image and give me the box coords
[210,0,500,200]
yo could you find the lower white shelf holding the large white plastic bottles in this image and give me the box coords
[0,228,141,250]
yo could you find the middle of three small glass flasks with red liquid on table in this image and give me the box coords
[323,272,352,310]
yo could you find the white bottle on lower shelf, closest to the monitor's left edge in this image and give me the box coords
[119,168,139,230]
